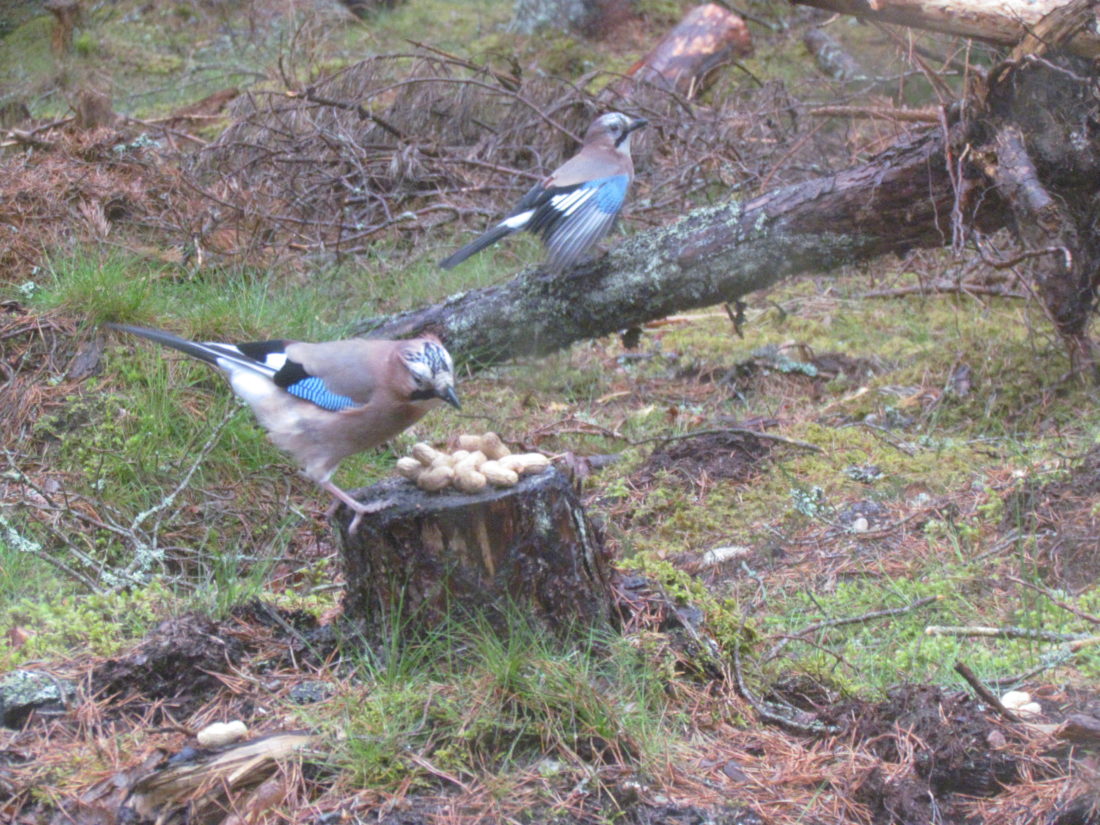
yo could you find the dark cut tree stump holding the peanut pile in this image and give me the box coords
[337,469,611,634]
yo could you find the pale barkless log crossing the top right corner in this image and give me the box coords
[791,0,1100,57]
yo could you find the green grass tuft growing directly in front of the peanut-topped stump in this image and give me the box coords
[325,613,675,789]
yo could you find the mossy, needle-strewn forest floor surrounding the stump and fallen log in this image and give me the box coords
[0,0,1100,825]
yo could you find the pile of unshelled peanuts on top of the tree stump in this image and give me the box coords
[397,432,550,493]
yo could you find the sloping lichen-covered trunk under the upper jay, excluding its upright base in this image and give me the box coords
[358,123,1004,365]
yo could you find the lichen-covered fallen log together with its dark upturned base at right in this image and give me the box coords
[356,0,1100,372]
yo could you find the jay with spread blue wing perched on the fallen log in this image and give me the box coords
[439,112,648,272]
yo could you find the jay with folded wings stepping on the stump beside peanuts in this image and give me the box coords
[107,323,460,532]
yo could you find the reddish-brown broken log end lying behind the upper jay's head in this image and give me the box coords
[613,3,752,98]
